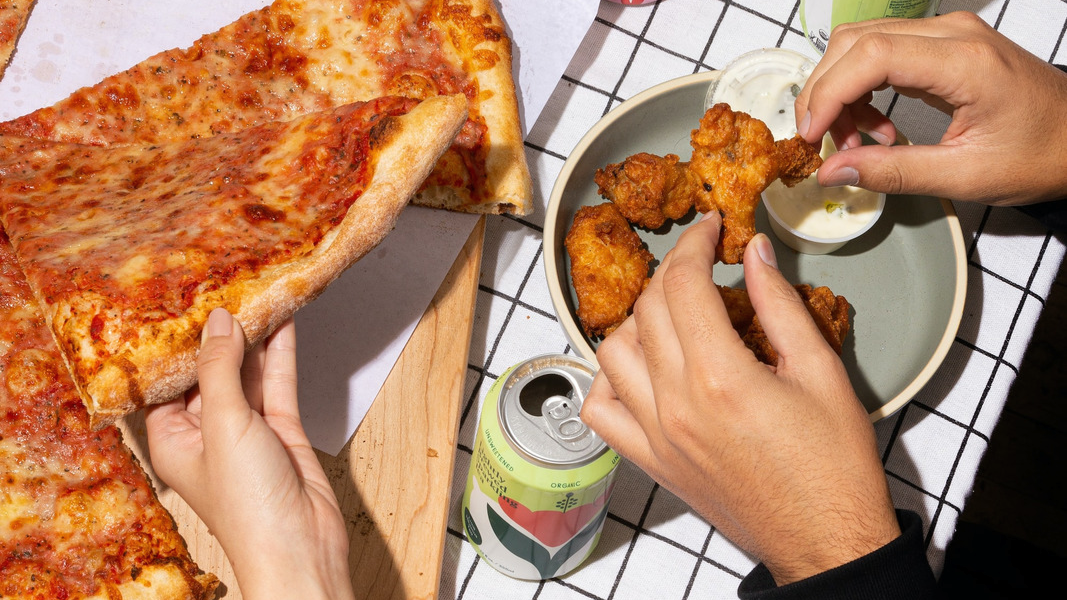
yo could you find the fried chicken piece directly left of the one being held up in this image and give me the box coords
[593,153,701,230]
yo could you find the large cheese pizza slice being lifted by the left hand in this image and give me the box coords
[0,95,466,425]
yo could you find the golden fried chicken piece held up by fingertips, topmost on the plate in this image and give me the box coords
[689,104,778,264]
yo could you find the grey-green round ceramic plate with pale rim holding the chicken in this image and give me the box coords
[543,72,967,420]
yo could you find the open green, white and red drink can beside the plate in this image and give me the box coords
[462,354,620,580]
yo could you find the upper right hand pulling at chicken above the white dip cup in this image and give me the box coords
[795,12,1067,205]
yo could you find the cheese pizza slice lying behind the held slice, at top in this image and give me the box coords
[0,0,531,215]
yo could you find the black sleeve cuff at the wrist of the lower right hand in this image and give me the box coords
[737,510,937,600]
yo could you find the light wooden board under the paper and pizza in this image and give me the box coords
[121,217,485,600]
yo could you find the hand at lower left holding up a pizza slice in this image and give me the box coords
[145,309,353,599]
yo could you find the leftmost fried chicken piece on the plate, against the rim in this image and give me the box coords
[563,202,653,336]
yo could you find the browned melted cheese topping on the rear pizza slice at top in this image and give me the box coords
[0,0,475,143]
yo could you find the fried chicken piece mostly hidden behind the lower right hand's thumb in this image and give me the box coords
[719,284,851,366]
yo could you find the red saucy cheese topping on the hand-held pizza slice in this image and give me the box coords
[0,97,407,318]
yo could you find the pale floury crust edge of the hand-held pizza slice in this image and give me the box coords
[76,96,466,427]
